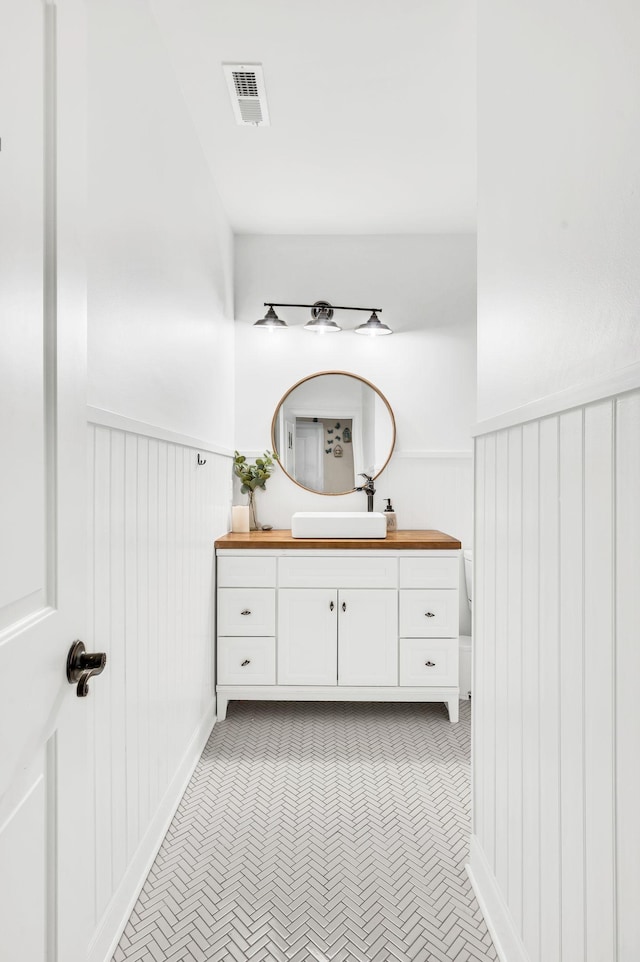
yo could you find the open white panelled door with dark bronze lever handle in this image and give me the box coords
[0,0,91,962]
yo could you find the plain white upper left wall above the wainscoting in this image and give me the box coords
[88,0,233,447]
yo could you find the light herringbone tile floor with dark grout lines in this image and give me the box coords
[113,702,496,962]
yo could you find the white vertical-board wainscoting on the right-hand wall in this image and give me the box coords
[470,391,640,962]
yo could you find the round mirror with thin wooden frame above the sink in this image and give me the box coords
[271,371,396,494]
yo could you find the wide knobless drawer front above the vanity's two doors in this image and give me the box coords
[278,556,398,588]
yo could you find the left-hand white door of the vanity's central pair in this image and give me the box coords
[278,588,338,685]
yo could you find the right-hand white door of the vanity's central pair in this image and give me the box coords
[338,588,398,685]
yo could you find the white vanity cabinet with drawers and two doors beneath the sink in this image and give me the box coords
[216,532,460,722]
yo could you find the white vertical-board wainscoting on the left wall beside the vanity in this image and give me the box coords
[87,424,232,962]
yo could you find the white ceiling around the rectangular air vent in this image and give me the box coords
[151,0,476,234]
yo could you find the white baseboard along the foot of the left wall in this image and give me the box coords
[87,706,215,962]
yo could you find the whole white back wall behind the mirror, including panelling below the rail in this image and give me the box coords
[235,234,476,633]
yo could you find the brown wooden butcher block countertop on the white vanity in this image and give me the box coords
[215,528,462,551]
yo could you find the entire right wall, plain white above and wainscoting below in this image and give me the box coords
[471,0,640,962]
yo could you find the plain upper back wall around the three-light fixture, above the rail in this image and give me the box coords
[236,234,476,456]
